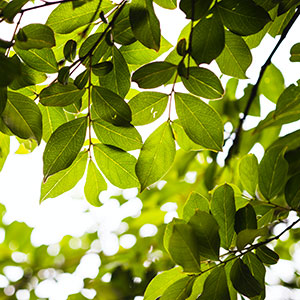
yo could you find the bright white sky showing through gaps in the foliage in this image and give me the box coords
[0,4,300,300]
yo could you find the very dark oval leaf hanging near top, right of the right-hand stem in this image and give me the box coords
[191,15,225,65]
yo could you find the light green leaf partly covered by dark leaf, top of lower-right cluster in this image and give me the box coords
[182,192,209,221]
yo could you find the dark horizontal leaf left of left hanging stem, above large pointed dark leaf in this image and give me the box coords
[40,82,85,106]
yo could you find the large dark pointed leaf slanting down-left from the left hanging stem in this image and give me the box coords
[43,117,87,182]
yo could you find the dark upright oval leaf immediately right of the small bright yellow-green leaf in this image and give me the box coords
[258,146,288,200]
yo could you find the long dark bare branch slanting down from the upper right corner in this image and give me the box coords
[225,6,300,164]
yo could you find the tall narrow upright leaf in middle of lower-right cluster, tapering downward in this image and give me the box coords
[211,184,235,249]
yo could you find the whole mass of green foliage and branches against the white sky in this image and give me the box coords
[0,0,300,300]
